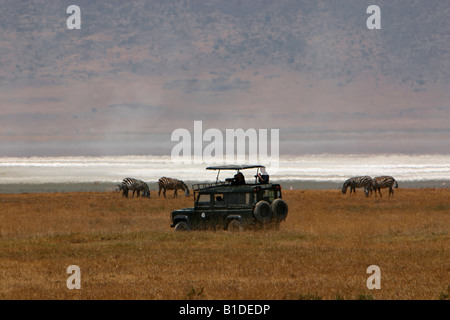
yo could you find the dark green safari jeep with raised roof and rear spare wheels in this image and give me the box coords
[171,166,288,231]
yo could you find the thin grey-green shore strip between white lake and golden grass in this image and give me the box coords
[0,180,450,194]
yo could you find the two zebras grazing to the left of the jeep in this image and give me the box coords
[118,177,189,198]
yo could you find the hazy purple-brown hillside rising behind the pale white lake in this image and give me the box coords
[0,0,450,156]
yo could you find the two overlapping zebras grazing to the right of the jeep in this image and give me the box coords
[342,176,398,197]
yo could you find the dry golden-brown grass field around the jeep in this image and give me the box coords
[0,189,450,300]
